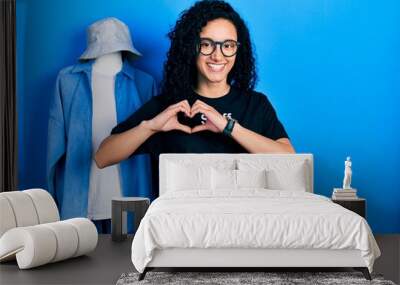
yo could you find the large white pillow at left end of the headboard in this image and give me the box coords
[167,163,211,191]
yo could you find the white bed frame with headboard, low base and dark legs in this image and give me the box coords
[139,154,371,280]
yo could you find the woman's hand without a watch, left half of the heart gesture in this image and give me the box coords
[148,100,191,134]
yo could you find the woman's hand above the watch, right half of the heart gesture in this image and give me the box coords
[190,100,227,133]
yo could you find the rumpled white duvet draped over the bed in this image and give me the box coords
[132,189,380,272]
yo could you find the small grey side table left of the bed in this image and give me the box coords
[111,197,150,241]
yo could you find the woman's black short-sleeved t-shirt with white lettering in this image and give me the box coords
[111,87,288,197]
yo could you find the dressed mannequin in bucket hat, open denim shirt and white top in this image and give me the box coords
[46,17,157,229]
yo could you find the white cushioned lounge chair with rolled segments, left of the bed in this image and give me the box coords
[0,189,98,269]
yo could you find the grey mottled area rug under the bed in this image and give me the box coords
[117,271,395,285]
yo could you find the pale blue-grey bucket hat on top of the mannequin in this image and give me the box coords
[79,17,142,60]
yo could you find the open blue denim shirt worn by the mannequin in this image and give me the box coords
[47,59,157,219]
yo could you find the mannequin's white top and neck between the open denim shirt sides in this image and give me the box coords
[88,52,122,232]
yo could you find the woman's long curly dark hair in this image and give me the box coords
[161,0,257,102]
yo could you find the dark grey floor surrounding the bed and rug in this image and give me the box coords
[0,234,400,285]
